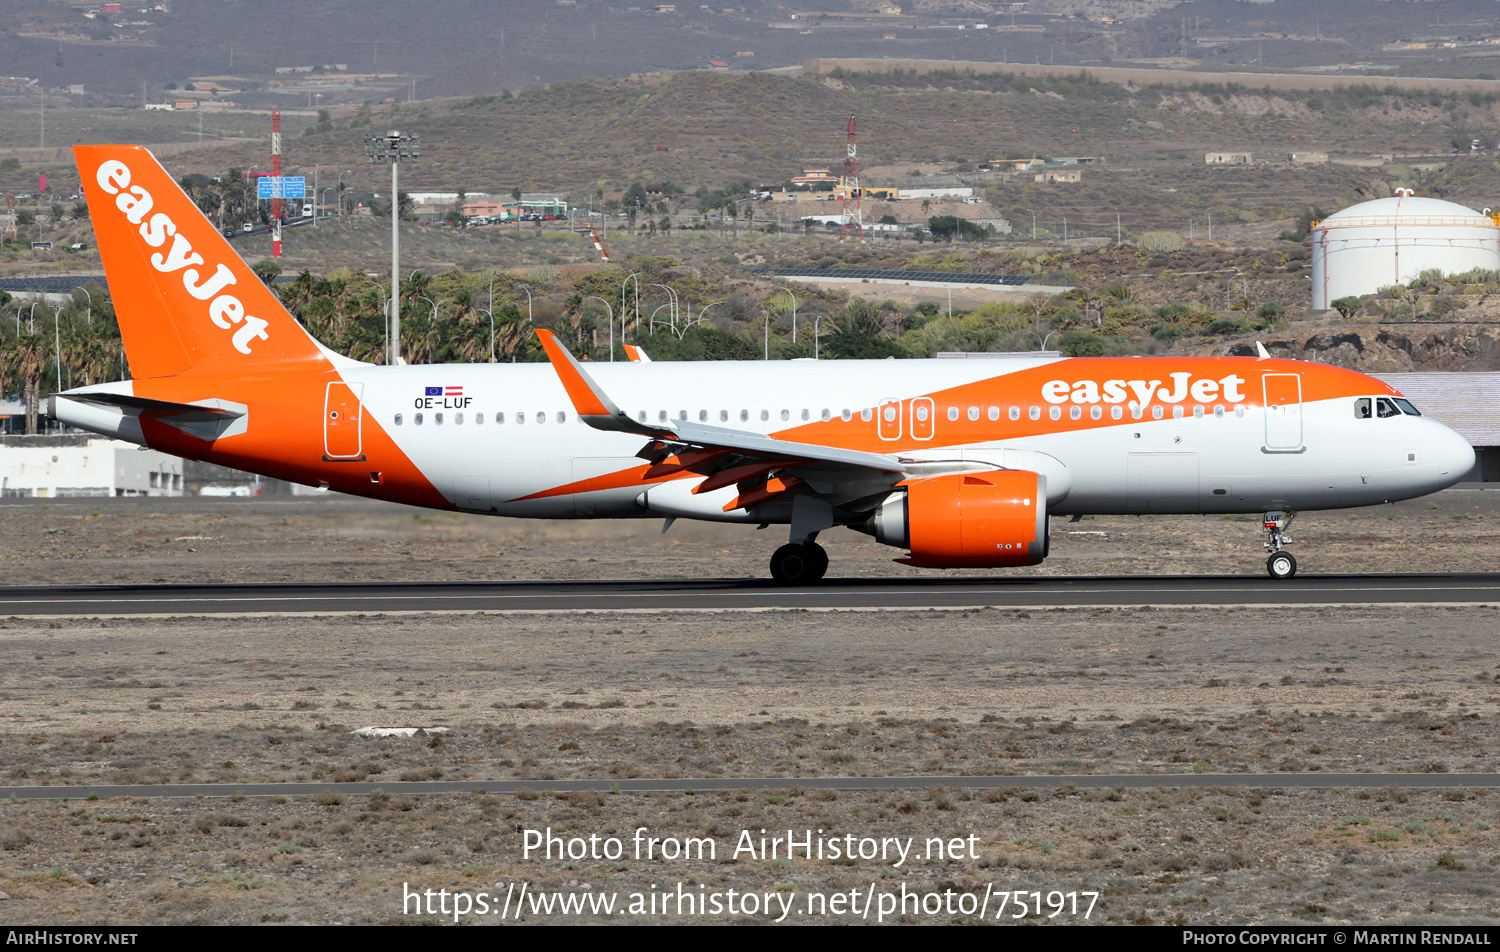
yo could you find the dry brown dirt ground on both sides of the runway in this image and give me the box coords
[0,487,1500,924]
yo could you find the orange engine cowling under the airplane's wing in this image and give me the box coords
[873,469,1049,568]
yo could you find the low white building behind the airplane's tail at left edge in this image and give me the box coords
[0,435,183,498]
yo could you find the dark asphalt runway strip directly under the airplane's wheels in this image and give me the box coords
[0,573,1500,618]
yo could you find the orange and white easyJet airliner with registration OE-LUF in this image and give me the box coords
[48,145,1475,582]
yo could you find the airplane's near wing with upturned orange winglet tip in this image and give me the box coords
[537,328,908,505]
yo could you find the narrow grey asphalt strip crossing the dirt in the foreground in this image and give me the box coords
[0,772,1500,801]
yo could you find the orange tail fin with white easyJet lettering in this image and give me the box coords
[74,145,324,378]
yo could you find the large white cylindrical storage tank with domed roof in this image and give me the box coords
[1311,189,1500,310]
